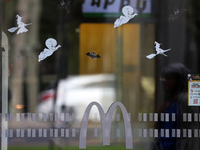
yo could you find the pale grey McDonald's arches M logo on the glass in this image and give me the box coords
[79,102,133,149]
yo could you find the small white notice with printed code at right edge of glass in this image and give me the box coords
[188,74,200,106]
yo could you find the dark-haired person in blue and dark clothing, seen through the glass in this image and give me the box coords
[154,63,199,150]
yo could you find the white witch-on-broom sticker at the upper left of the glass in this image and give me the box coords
[8,15,32,34]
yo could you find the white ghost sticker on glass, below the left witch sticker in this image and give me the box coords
[38,38,61,62]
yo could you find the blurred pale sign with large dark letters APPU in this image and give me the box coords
[82,0,151,17]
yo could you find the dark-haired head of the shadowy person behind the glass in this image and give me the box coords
[161,63,190,93]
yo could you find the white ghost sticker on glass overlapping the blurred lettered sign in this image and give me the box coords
[114,6,138,28]
